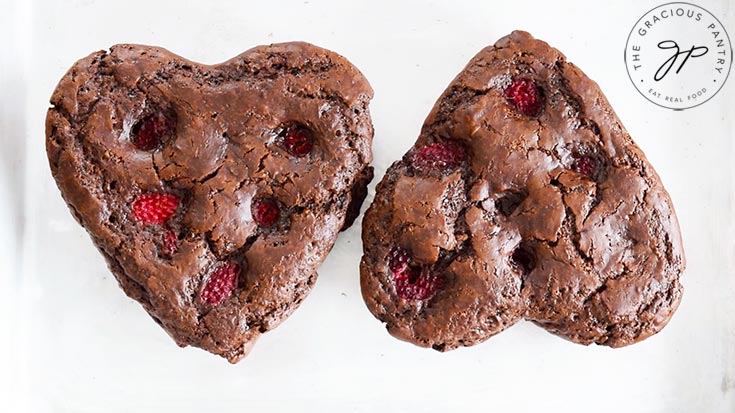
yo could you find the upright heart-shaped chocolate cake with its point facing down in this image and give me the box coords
[46,43,373,362]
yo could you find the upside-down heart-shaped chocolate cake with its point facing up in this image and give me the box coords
[361,32,685,350]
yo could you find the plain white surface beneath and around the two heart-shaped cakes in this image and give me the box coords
[0,0,735,413]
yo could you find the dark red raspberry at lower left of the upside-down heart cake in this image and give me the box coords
[388,247,444,301]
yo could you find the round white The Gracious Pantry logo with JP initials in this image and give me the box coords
[625,2,732,110]
